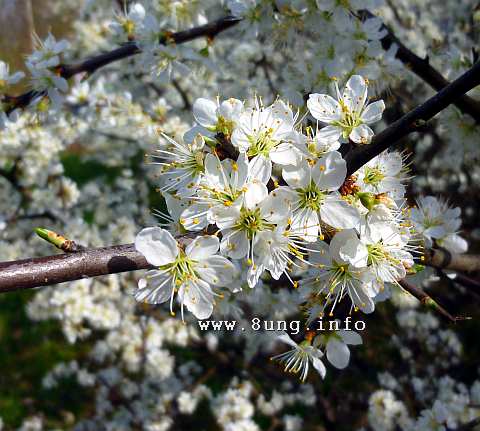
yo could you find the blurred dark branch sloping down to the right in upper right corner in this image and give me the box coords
[358,10,480,124]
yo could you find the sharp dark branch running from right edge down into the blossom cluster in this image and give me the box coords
[345,61,480,176]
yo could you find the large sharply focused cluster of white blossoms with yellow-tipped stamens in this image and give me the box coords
[129,75,464,379]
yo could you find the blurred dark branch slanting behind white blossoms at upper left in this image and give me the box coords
[4,16,241,113]
